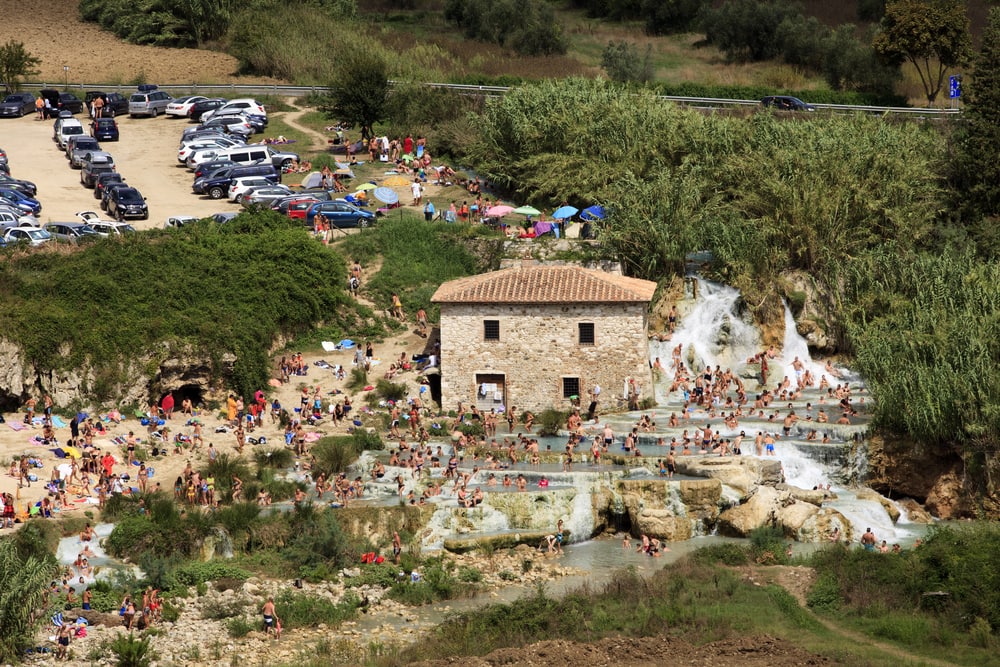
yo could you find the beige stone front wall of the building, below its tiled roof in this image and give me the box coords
[441,303,653,412]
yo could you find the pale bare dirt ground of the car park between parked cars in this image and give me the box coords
[0,114,250,229]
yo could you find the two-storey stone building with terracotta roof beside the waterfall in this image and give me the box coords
[431,263,656,412]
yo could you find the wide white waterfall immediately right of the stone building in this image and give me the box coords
[650,279,760,376]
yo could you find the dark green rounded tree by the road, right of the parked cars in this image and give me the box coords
[321,49,389,127]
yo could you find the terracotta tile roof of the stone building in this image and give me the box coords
[431,265,656,303]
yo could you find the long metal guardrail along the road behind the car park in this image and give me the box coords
[24,81,962,118]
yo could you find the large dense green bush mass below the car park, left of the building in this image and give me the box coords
[0,212,357,400]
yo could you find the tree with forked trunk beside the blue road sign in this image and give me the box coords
[872,0,972,106]
